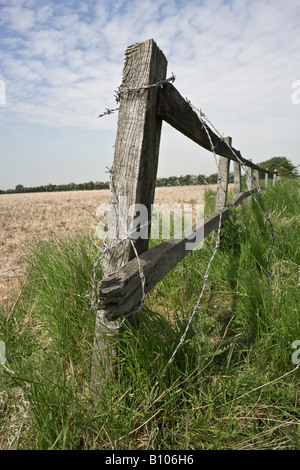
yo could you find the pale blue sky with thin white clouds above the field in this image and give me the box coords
[0,0,300,189]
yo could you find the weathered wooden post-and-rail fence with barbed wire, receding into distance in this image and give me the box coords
[91,40,277,391]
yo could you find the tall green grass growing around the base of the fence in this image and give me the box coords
[0,180,300,450]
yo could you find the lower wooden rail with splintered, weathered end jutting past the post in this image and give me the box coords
[98,189,256,321]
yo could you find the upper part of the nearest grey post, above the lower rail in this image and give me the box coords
[103,40,167,274]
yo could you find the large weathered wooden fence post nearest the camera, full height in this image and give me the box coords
[91,39,167,398]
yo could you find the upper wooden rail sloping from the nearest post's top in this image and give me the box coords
[157,83,274,175]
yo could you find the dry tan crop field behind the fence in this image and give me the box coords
[0,185,230,303]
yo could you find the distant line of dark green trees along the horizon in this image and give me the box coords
[0,157,299,194]
